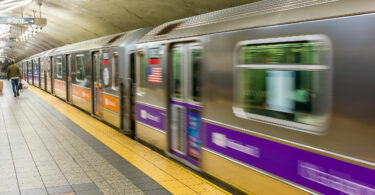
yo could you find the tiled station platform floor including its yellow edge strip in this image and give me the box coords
[0,81,229,195]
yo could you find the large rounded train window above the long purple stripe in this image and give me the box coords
[233,36,330,132]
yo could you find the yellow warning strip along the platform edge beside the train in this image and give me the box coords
[29,86,230,195]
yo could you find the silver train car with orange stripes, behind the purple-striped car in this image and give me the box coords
[44,29,151,129]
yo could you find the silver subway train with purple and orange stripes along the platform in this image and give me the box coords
[19,0,375,194]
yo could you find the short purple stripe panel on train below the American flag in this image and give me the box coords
[136,104,165,131]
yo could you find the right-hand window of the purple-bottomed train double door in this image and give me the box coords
[189,44,202,102]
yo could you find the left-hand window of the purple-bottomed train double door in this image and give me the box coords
[172,45,184,98]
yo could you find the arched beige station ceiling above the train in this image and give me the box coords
[0,0,258,61]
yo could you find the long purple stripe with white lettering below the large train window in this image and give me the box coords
[205,123,375,194]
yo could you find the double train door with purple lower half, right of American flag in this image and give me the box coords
[169,43,202,166]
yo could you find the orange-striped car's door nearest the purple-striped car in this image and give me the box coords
[91,51,102,117]
